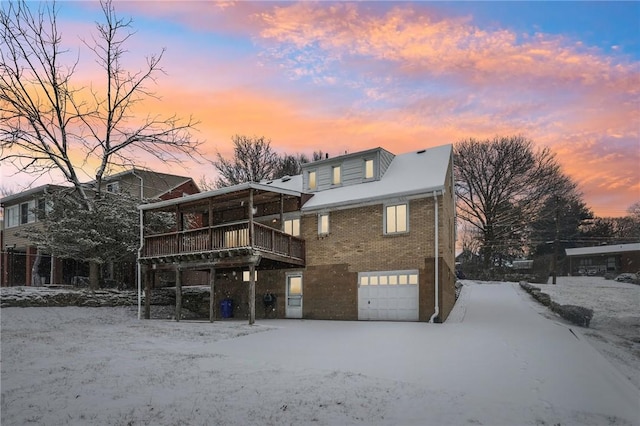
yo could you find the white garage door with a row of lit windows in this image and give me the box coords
[358,270,418,321]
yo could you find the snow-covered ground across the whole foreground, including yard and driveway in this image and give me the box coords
[0,281,640,426]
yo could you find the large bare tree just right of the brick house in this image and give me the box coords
[454,136,567,268]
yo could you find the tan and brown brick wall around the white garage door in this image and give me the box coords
[301,192,455,321]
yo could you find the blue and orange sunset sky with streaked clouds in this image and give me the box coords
[0,1,640,216]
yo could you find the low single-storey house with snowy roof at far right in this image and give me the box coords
[565,243,640,275]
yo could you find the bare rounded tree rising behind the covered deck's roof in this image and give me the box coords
[213,135,280,188]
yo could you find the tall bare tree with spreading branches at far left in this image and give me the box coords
[0,0,199,286]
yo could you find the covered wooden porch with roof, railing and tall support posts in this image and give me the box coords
[138,183,305,324]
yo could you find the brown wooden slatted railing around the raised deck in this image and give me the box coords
[143,221,304,260]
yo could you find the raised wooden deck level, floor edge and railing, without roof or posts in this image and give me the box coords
[140,221,305,266]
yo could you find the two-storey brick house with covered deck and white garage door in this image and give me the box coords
[139,145,455,321]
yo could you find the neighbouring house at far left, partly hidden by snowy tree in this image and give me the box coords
[0,169,199,286]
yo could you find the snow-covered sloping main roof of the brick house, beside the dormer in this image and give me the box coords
[302,145,452,212]
